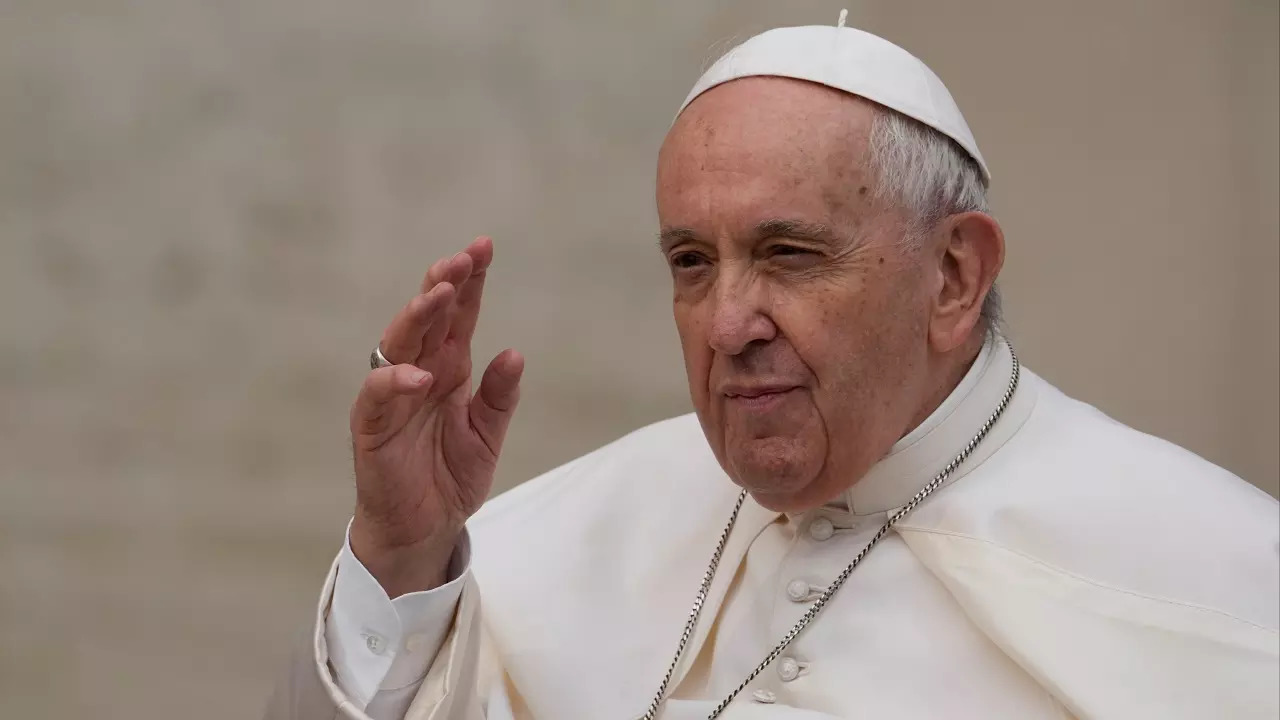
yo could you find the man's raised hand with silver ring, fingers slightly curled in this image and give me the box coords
[351,237,524,597]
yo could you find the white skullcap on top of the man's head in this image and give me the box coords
[677,26,991,182]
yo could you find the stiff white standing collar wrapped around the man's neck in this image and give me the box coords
[833,333,1030,515]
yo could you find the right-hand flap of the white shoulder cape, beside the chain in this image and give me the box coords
[902,373,1280,628]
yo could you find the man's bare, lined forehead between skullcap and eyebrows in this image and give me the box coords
[657,77,874,224]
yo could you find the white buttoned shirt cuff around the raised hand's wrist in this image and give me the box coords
[325,525,471,720]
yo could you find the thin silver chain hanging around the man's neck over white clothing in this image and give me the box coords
[637,347,1021,720]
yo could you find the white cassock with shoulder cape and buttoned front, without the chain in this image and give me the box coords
[272,340,1280,720]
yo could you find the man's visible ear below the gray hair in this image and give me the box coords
[929,213,1005,352]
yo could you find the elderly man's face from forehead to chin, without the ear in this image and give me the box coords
[657,78,937,511]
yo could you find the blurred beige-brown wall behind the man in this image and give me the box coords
[0,0,1280,720]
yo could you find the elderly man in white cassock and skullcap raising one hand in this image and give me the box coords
[269,16,1280,720]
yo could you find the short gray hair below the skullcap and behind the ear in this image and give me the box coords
[870,108,1001,331]
